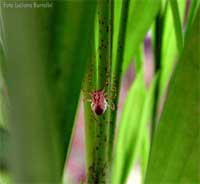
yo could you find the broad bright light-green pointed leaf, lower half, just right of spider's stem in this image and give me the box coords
[112,73,145,184]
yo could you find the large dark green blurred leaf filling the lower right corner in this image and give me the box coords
[146,8,200,184]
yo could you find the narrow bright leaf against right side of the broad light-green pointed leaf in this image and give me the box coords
[121,76,157,183]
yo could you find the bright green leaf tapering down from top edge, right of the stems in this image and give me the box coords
[122,0,161,72]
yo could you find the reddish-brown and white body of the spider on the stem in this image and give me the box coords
[91,90,108,116]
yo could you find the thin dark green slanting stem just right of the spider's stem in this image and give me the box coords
[109,0,130,162]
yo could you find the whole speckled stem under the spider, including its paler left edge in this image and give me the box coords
[84,0,113,184]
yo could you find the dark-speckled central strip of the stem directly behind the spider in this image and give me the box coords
[93,0,111,184]
